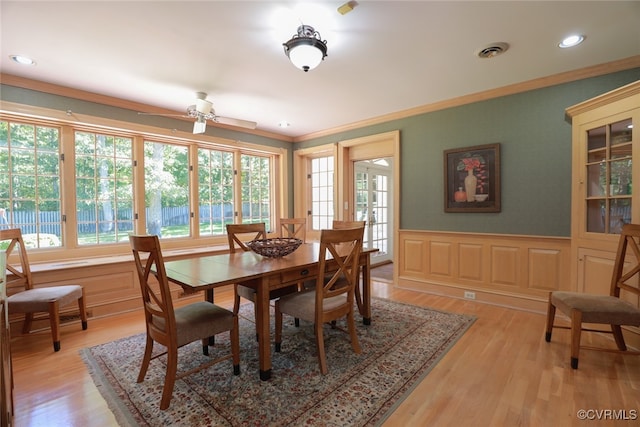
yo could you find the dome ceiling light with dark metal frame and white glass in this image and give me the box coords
[282,25,327,72]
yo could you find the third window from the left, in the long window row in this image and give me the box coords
[144,141,191,237]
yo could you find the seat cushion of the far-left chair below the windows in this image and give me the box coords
[7,285,82,313]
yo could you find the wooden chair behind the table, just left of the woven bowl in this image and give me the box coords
[227,222,298,337]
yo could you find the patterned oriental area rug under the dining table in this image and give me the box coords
[81,298,475,427]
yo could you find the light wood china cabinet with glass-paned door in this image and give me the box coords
[566,81,640,294]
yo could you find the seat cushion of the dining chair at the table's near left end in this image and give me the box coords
[174,301,233,346]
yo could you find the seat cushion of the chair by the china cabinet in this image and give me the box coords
[551,291,640,326]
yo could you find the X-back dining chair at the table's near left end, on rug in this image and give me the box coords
[129,235,240,410]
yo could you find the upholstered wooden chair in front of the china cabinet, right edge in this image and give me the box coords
[545,224,640,369]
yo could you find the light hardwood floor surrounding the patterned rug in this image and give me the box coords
[12,282,640,427]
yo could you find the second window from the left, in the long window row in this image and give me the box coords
[75,132,133,245]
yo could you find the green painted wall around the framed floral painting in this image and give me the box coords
[296,69,640,237]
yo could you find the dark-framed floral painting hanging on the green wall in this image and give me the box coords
[444,144,500,212]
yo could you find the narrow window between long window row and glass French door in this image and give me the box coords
[310,156,333,230]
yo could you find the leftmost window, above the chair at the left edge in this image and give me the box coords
[0,121,62,248]
